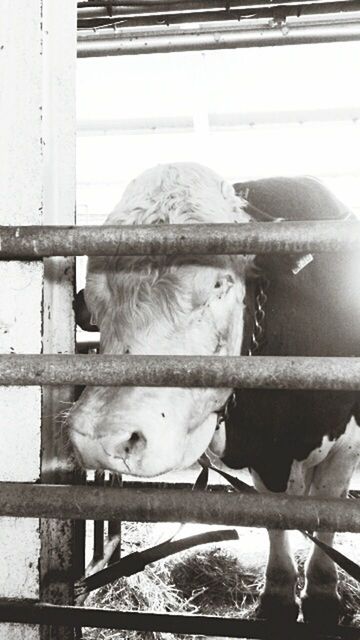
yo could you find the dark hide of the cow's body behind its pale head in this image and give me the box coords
[223,177,360,491]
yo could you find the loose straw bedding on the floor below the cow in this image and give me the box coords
[83,523,360,640]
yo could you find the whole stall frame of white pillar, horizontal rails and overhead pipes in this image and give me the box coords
[0,0,360,640]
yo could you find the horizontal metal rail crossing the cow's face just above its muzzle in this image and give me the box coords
[0,354,360,391]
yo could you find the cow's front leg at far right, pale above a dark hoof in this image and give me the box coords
[301,421,360,624]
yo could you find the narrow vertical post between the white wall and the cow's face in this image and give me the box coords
[40,0,85,640]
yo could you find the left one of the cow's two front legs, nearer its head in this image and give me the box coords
[252,472,299,622]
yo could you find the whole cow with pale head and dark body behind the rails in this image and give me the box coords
[68,163,360,621]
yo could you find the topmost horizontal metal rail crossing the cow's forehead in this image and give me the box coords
[0,220,360,259]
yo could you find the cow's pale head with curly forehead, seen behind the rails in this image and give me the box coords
[69,163,248,476]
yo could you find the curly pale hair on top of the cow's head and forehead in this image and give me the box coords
[85,163,248,342]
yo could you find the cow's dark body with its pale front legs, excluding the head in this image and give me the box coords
[211,177,360,626]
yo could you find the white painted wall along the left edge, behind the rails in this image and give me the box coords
[0,0,76,640]
